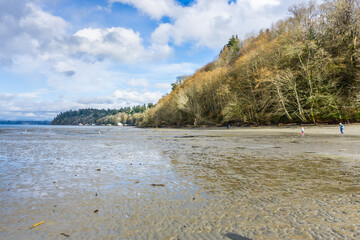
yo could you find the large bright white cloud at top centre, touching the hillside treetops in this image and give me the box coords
[149,0,286,49]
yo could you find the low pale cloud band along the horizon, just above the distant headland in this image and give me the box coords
[0,89,162,120]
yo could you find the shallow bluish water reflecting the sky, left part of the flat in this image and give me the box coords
[0,126,178,198]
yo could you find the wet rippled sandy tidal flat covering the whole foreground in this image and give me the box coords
[0,125,360,240]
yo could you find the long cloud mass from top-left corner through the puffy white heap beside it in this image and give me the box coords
[0,0,173,71]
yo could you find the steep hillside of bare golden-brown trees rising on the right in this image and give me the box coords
[138,0,360,127]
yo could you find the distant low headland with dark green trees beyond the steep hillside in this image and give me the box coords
[51,103,154,125]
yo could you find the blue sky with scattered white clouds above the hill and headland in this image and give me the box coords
[0,0,310,120]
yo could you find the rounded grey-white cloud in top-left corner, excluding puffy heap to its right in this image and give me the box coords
[0,0,68,65]
